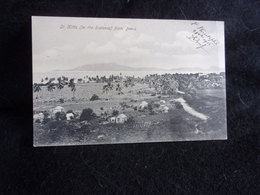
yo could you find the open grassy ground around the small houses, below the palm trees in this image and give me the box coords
[34,83,226,145]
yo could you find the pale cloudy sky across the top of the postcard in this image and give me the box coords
[32,16,225,72]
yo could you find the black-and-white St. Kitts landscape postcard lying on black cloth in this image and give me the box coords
[32,16,227,146]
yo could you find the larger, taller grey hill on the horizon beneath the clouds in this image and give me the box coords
[69,63,168,71]
